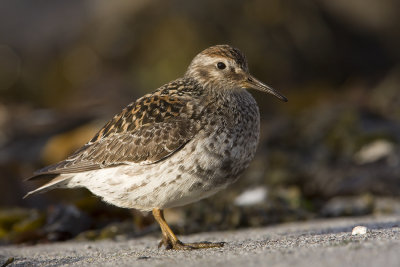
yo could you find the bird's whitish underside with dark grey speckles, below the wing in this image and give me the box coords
[69,125,258,210]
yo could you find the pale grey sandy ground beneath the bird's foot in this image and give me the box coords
[0,216,400,267]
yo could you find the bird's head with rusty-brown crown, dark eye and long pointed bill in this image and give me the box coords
[185,45,287,102]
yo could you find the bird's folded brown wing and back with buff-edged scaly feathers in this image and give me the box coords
[31,82,206,179]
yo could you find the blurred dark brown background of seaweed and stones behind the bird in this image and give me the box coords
[0,0,400,244]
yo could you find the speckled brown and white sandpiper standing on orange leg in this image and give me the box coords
[25,45,287,250]
